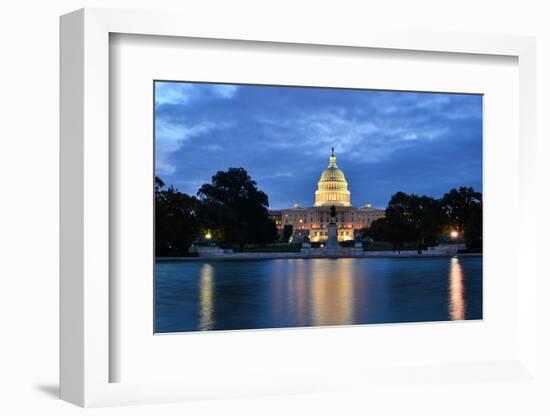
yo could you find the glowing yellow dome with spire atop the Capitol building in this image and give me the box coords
[315,147,350,207]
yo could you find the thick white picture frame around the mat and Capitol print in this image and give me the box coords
[60,9,537,407]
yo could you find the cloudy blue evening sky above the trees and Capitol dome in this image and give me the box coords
[155,82,482,208]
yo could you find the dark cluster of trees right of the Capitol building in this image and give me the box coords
[362,187,483,252]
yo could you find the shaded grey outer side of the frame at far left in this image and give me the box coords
[59,10,84,406]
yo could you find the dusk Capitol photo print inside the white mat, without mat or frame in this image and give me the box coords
[153,81,483,333]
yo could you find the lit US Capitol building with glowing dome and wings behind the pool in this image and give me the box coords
[269,148,384,242]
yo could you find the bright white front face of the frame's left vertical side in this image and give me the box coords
[81,9,110,407]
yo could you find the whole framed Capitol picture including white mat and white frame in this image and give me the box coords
[61,9,537,406]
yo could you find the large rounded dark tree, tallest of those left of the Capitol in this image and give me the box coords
[197,168,277,250]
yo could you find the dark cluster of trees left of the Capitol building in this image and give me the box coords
[155,168,277,256]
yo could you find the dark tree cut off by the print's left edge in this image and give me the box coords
[155,177,200,256]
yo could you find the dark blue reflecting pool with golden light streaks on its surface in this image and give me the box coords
[155,256,482,333]
